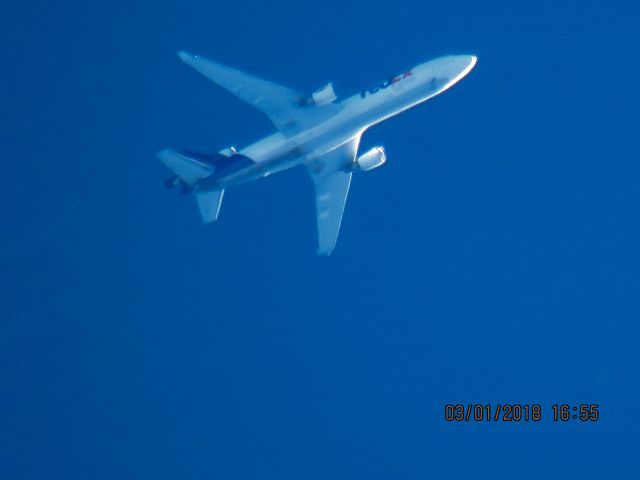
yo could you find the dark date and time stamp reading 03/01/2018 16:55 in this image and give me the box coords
[444,403,600,422]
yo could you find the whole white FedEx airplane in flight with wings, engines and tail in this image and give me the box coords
[158,51,477,255]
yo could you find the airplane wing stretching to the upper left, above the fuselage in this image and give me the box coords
[178,52,338,133]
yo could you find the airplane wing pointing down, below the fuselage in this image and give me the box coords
[306,135,360,255]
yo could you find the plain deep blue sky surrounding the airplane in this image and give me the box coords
[0,1,640,479]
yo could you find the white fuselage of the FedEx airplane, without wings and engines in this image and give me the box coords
[195,55,476,190]
